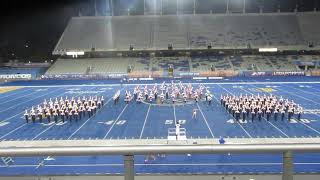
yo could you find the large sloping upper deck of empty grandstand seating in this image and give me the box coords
[54,13,320,54]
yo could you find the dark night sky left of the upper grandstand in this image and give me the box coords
[0,0,75,61]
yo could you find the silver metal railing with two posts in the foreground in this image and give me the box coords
[0,144,320,180]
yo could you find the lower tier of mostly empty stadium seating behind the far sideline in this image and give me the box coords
[46,55,320,77]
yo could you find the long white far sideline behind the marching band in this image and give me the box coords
[8,81,320,87]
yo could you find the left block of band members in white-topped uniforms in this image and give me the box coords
[24,96,104,123]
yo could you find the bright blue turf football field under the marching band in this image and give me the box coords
[0,79,320,175]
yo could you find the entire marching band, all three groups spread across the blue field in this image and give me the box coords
[24,82,303,123]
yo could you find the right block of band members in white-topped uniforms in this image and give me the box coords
[220,94,303,122]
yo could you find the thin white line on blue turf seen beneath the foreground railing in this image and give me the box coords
[0,162,320,168]
